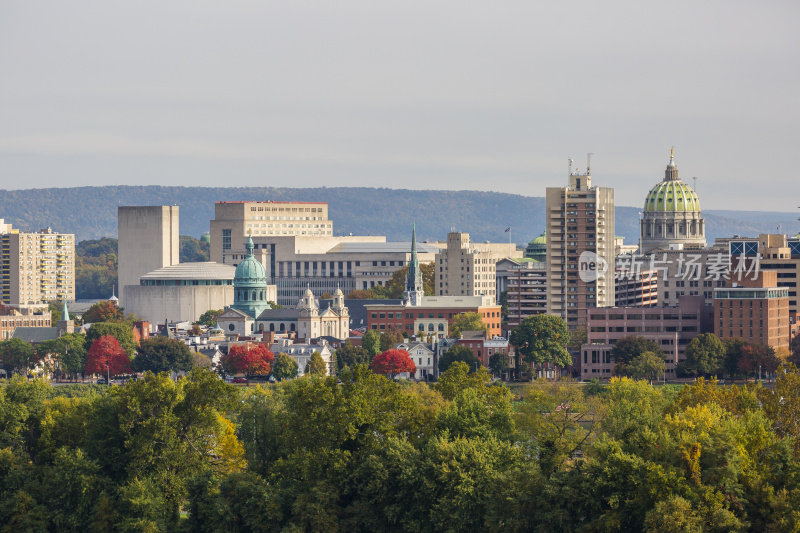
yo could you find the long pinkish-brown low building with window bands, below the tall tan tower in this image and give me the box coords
[576,295,713,380]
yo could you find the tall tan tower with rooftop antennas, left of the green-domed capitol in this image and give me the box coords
[546,160,614,329]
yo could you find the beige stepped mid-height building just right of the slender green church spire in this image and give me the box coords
[434,231,522,299]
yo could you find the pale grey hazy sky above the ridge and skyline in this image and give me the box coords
[0,0,800,211]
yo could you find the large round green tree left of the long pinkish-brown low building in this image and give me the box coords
[509,315,572,367]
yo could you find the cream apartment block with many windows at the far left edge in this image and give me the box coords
[0,219,75,305]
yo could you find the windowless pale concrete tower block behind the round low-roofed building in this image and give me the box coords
[117,205,180,306]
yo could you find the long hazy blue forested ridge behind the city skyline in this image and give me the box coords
[0,185,800,243]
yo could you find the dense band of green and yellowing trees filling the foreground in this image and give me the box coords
[7,362,800,532]
